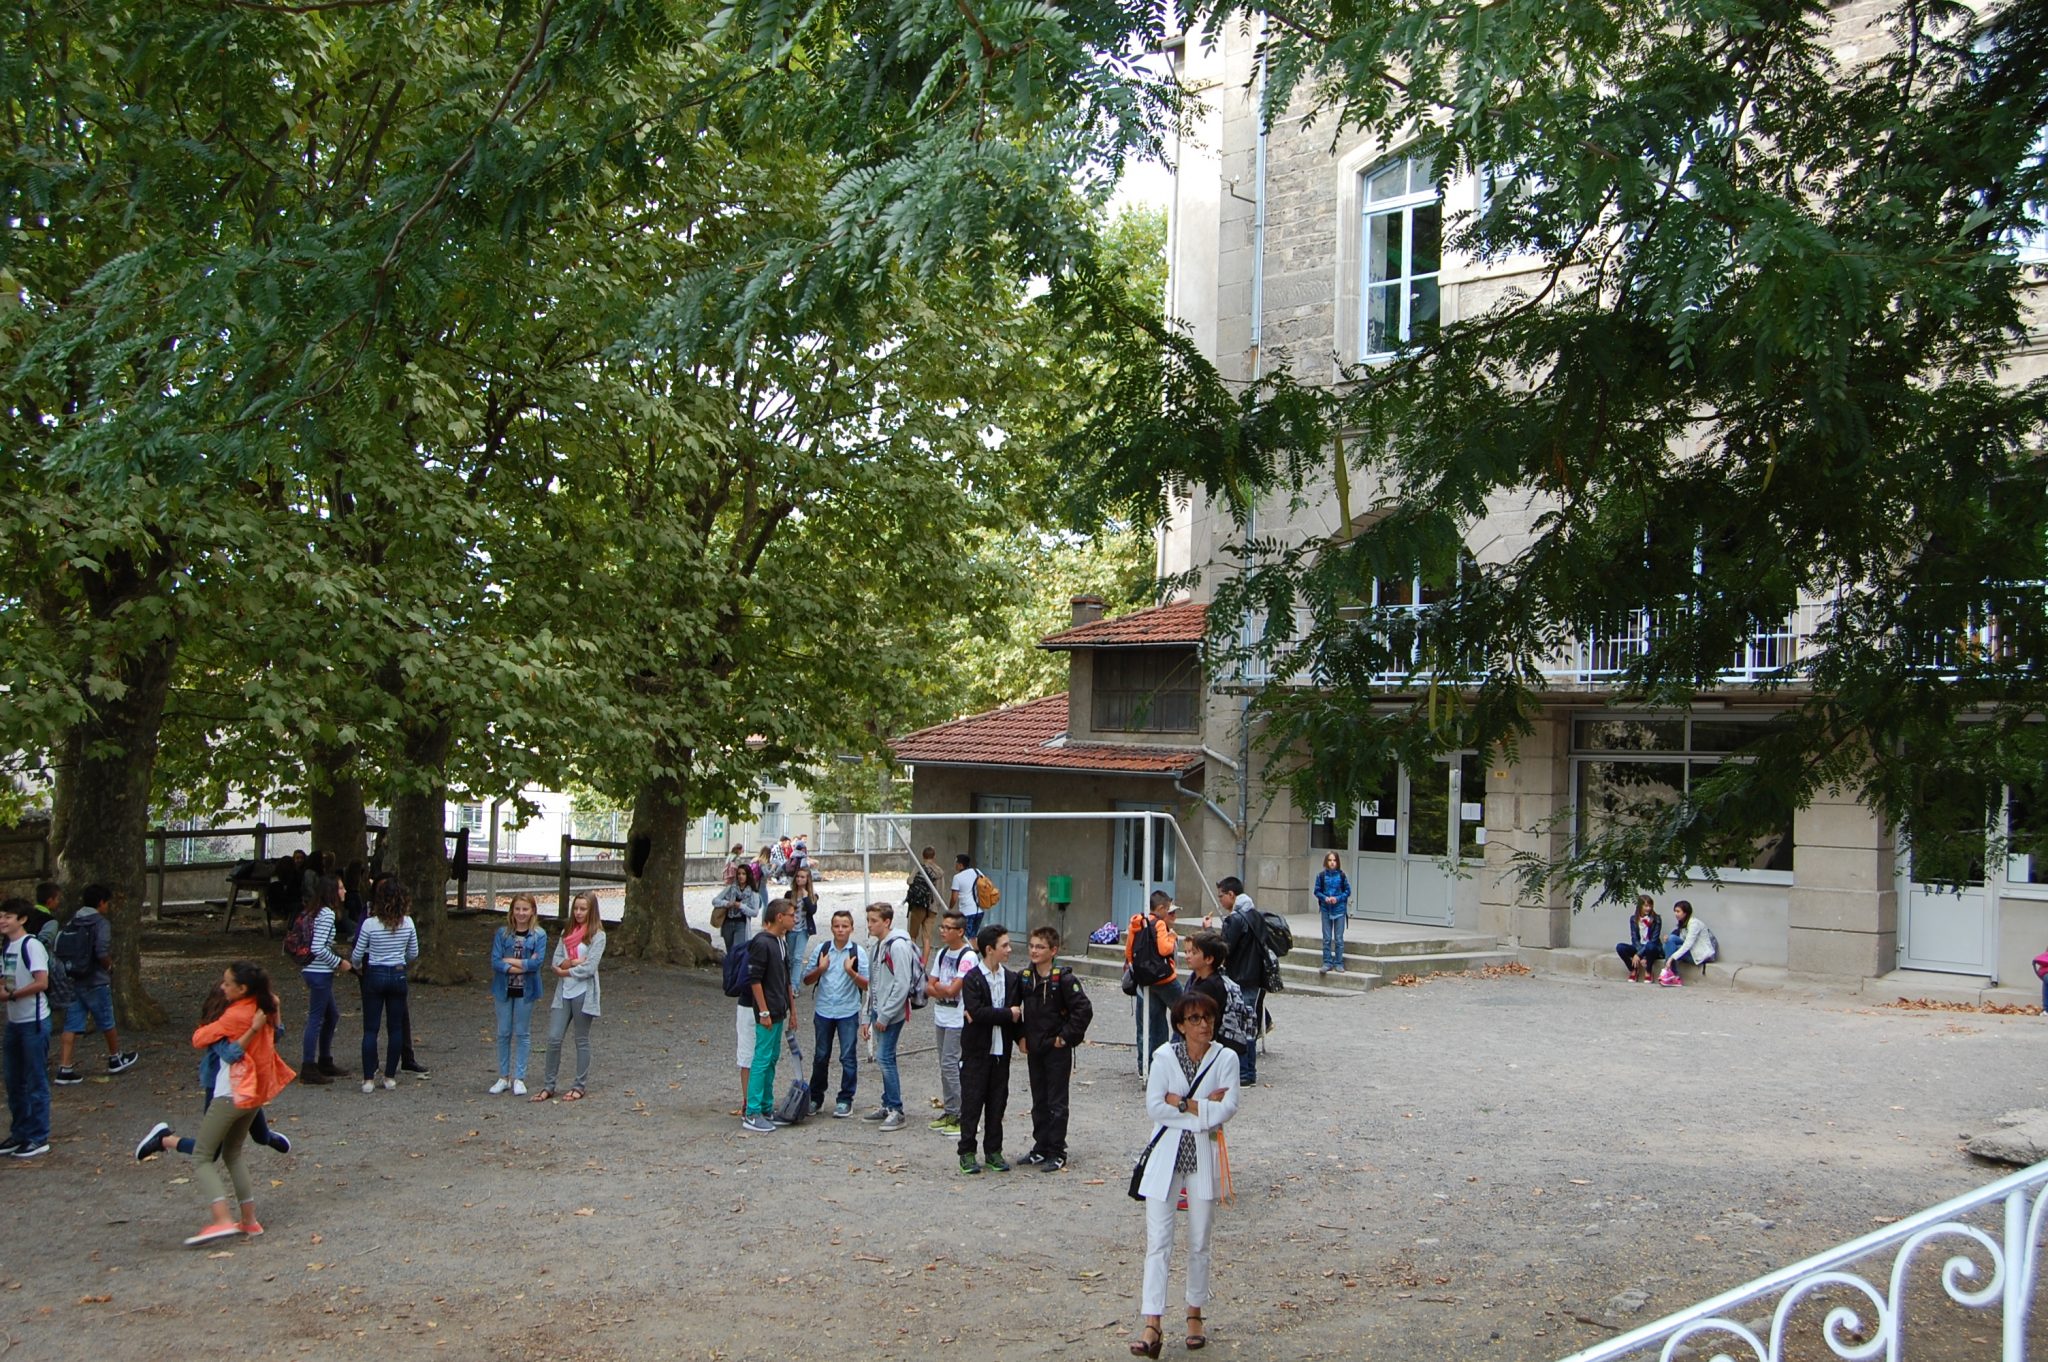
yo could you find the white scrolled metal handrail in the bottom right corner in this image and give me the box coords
[1563,1163,2048,1362]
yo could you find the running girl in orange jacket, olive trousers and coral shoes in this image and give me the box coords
[148,961,299,1247]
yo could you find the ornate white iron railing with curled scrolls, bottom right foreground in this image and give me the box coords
[1565,1163,2048,1362]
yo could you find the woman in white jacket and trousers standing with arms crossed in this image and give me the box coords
[1130,993,1237,1358]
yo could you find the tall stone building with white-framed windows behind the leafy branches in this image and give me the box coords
[1161,4,2048,989]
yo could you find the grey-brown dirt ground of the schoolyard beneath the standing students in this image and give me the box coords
[0,901,2048,1362]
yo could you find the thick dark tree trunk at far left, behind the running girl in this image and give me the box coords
[49,639,178,1028]
